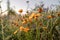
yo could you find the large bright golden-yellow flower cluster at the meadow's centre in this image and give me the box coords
[22,13,42,24]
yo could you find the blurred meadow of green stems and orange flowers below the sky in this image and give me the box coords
[0,0,60,40]
